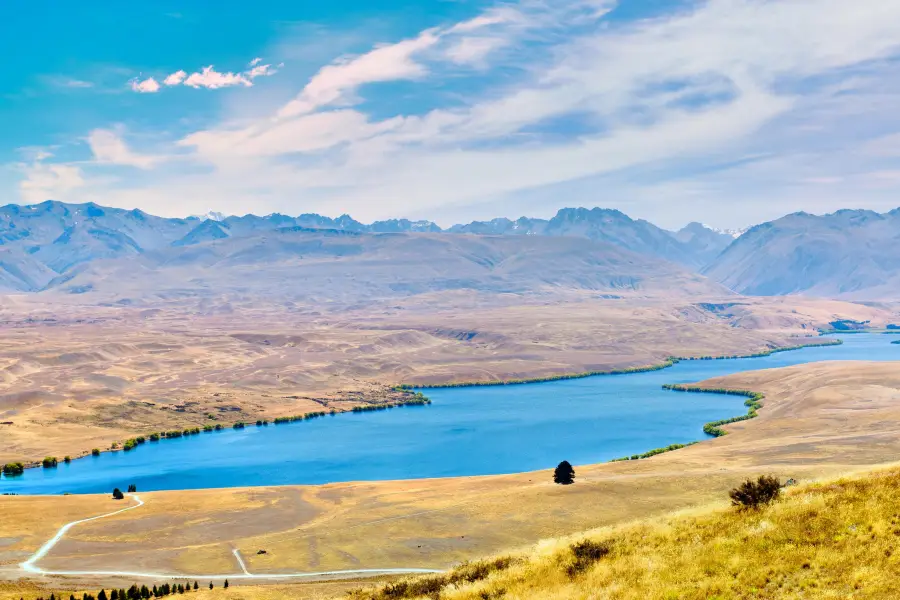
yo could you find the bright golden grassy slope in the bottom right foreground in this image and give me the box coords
[353,468,900,600]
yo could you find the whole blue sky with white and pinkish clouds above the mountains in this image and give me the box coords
[0,0,900,228]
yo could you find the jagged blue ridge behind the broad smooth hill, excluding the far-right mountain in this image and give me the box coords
[0,200,732,291]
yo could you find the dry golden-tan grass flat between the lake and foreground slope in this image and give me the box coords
[0,362,900,597]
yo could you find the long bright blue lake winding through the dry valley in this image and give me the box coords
[0,334,900,494]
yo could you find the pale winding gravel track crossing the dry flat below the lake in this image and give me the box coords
[19,495,441,580]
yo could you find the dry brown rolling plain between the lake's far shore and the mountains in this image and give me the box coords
[0,292,900,463]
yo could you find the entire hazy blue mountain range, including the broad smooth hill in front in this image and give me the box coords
[0,201,900,299]
